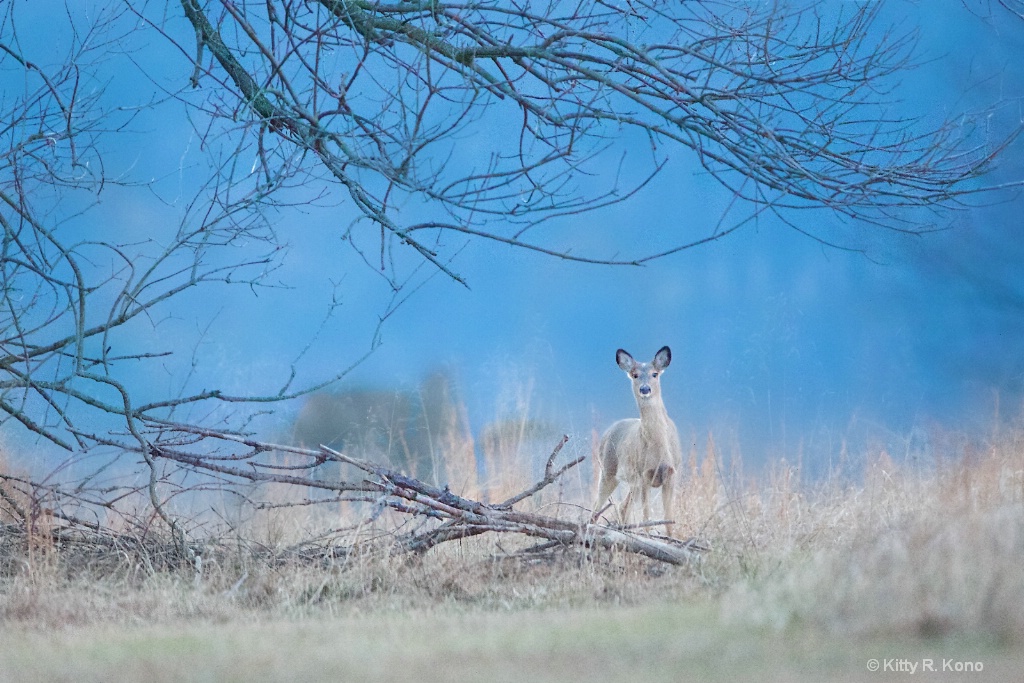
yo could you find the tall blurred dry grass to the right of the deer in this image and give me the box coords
[723,431,1024,642]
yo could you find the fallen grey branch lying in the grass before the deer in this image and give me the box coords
[29,423,708,564]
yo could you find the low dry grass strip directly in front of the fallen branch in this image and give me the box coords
[0,520,701,630]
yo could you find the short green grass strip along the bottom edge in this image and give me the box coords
[0,604,1024,683]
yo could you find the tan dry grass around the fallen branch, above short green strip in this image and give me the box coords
[0,419,1024,642]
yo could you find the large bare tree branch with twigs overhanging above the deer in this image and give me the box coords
[165,0,1016,282]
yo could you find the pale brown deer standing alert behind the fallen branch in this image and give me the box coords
[591,346,683,537]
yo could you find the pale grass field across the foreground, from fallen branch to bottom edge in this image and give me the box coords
[0,433,1024,681]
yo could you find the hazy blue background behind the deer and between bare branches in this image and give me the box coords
[6,3,1024,479]
